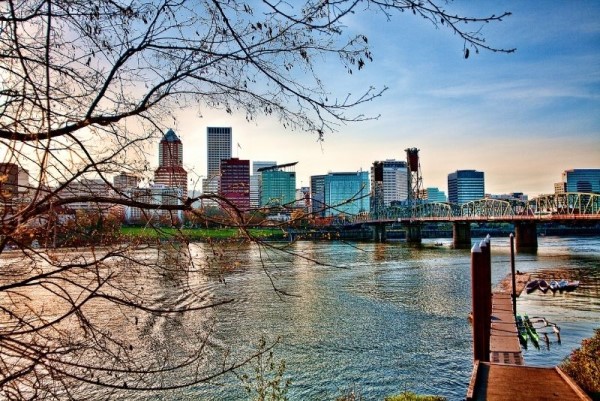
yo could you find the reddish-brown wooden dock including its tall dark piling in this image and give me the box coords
[466,236,591,401]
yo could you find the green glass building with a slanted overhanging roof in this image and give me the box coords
[258,162,298,208]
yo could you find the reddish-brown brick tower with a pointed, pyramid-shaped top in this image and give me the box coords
[154,129,187,196]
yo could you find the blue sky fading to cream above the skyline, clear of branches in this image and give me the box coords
[168,0,600,198]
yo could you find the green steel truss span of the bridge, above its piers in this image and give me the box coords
[346,192,600,224]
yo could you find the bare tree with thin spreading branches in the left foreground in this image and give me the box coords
[0,0,513,399]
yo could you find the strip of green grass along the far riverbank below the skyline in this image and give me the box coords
[121,227,285,241]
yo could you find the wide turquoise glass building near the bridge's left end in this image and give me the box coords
[324,171,370,216]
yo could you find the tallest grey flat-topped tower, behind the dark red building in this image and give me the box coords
[202,127,231,194]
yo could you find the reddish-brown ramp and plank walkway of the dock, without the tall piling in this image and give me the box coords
[466,275,591,401]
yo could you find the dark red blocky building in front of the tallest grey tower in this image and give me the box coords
[219,157,250,211]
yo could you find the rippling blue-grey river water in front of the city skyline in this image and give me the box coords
[4,237,600,401]
